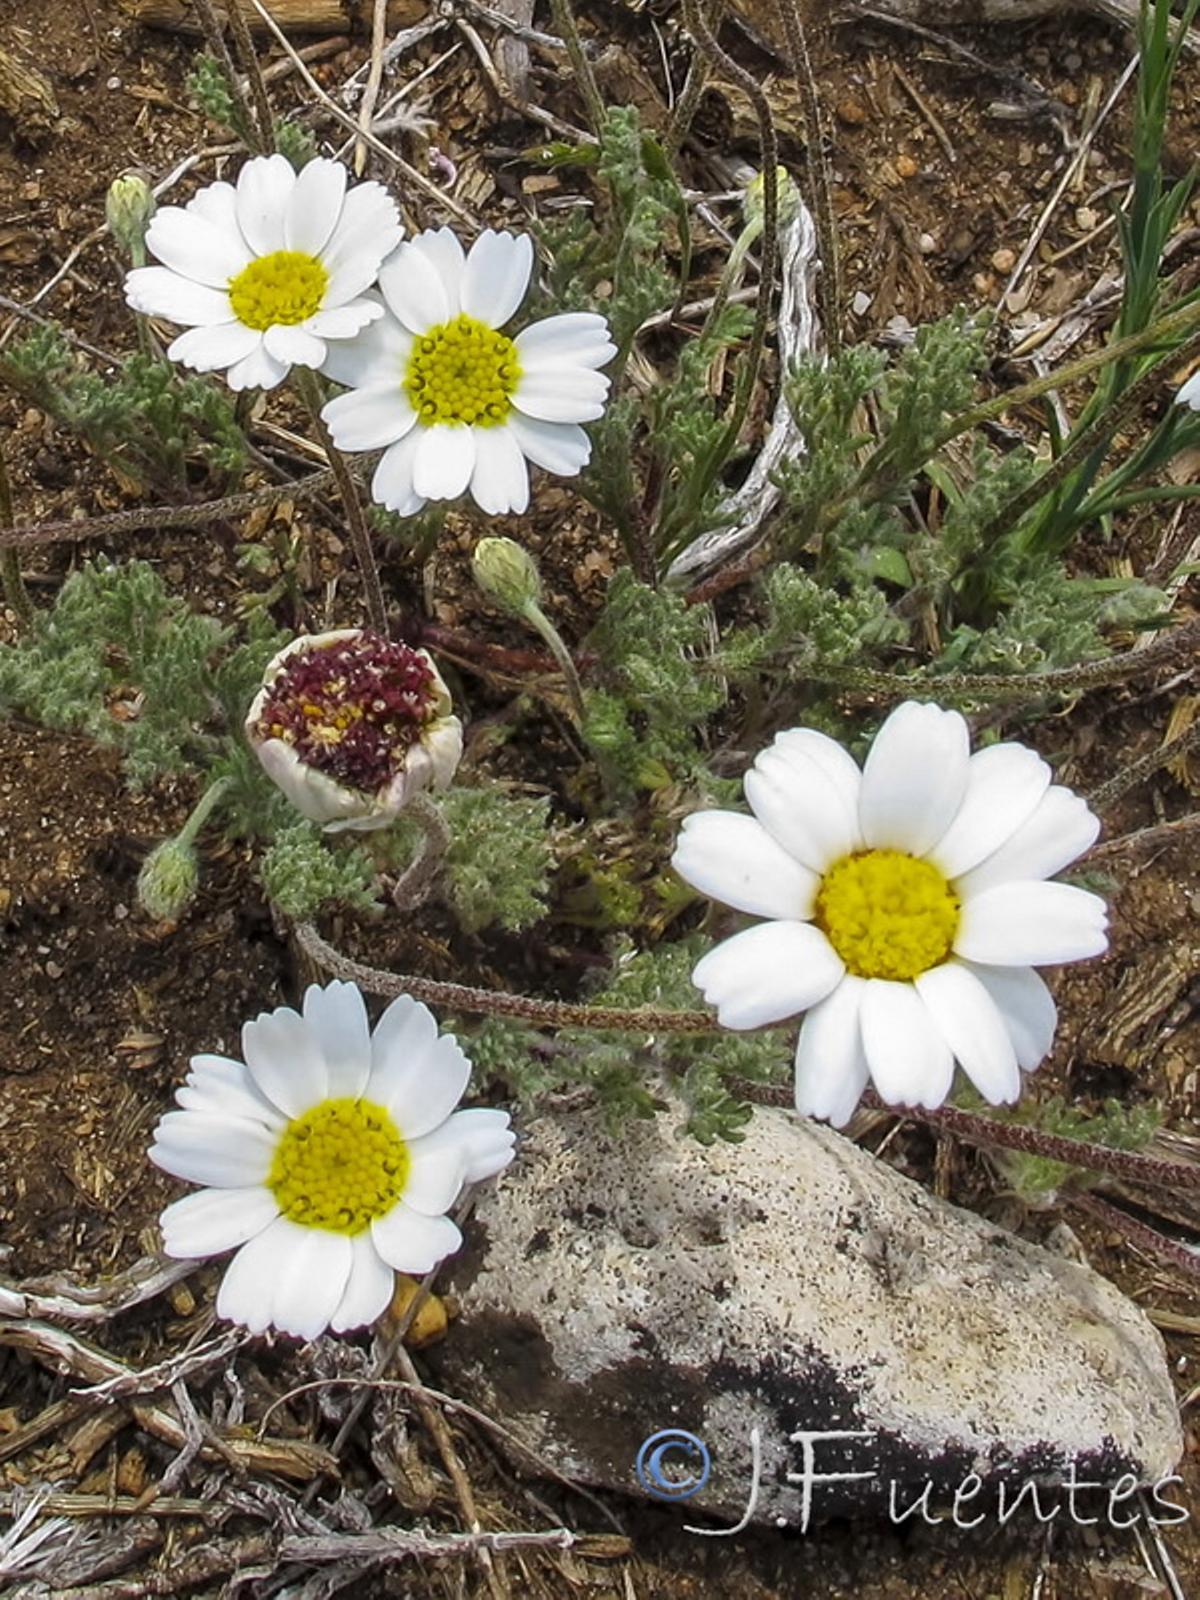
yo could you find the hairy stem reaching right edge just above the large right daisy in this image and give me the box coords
[798,618,1200,707]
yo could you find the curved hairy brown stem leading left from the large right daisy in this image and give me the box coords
[293,922,718,1034]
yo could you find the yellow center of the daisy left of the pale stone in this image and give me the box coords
[267,1099,410,1234]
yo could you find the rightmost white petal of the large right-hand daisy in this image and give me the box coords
[954,883,1109,966]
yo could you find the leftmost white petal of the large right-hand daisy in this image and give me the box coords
[670,811,818,922]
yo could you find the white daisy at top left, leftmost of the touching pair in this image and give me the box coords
[125,155,403,389]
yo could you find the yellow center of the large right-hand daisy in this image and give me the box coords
[816,850,960,981]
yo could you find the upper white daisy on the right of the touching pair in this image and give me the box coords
[322,227,616,517]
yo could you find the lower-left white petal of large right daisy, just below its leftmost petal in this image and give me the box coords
[691,922,845,1029]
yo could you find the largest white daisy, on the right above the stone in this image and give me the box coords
[672,701,1107,1126]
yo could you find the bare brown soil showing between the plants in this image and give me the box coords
[0,0,1200,1600]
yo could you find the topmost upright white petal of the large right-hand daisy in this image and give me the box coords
[859,701,970,856]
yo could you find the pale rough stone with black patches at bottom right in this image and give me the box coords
[437,1109,1182,1525]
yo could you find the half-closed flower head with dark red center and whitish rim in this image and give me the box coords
[246,627,462,834]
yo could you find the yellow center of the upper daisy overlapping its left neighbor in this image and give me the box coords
[403,315,522,427]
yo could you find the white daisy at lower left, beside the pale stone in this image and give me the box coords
[150,982,514,1339]
